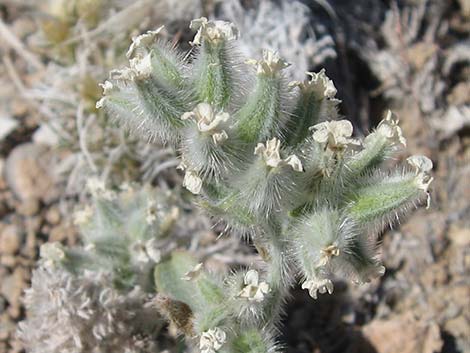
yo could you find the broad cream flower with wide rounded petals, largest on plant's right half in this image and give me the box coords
[312,120,359,150]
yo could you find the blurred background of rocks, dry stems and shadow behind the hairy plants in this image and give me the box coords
[0,0,470,353]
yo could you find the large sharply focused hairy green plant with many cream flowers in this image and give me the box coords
[97,18,432,353]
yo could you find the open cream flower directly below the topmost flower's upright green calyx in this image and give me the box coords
[181,103,230,145]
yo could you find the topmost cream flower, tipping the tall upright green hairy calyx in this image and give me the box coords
[189,17,239,45]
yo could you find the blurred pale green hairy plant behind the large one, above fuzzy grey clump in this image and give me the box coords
[70,179,180,292]
